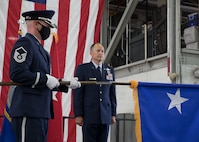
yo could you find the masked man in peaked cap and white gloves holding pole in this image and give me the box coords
[9,10,81,142]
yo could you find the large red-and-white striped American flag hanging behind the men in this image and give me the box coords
[0,0,104,142]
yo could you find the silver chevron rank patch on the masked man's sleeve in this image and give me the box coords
[14,46,27,63]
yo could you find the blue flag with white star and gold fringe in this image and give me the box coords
[133,82,199,142]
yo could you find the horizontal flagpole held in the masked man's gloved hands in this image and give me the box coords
[0,81,131,86]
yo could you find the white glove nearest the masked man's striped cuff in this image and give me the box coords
[46,74,60,90]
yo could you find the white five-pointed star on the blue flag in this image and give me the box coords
[167,88,189,114]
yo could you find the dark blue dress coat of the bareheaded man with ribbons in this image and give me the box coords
[74,62,117,124]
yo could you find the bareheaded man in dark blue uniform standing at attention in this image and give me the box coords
[73,43,117,142]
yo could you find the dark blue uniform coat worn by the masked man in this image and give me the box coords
[9,33,53,118]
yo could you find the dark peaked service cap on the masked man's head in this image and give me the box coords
[22,10,56,28]
